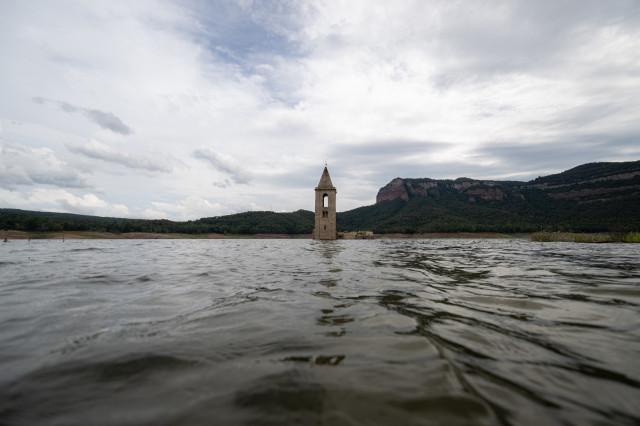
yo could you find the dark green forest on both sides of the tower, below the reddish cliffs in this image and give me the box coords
[0,188,640,234]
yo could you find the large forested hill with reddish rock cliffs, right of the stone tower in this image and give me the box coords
[338,161,640,233]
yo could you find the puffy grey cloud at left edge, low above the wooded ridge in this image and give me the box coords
[0,141,90,188]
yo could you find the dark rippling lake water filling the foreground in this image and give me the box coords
[0,240,640,425]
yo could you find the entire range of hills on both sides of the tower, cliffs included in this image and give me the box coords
[0,161,640,234]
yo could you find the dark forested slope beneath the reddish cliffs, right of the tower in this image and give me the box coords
[350,193,640,234]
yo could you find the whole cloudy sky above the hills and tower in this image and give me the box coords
[0,0,640,220]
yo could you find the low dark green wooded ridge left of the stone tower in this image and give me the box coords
[0,209,314,234]
